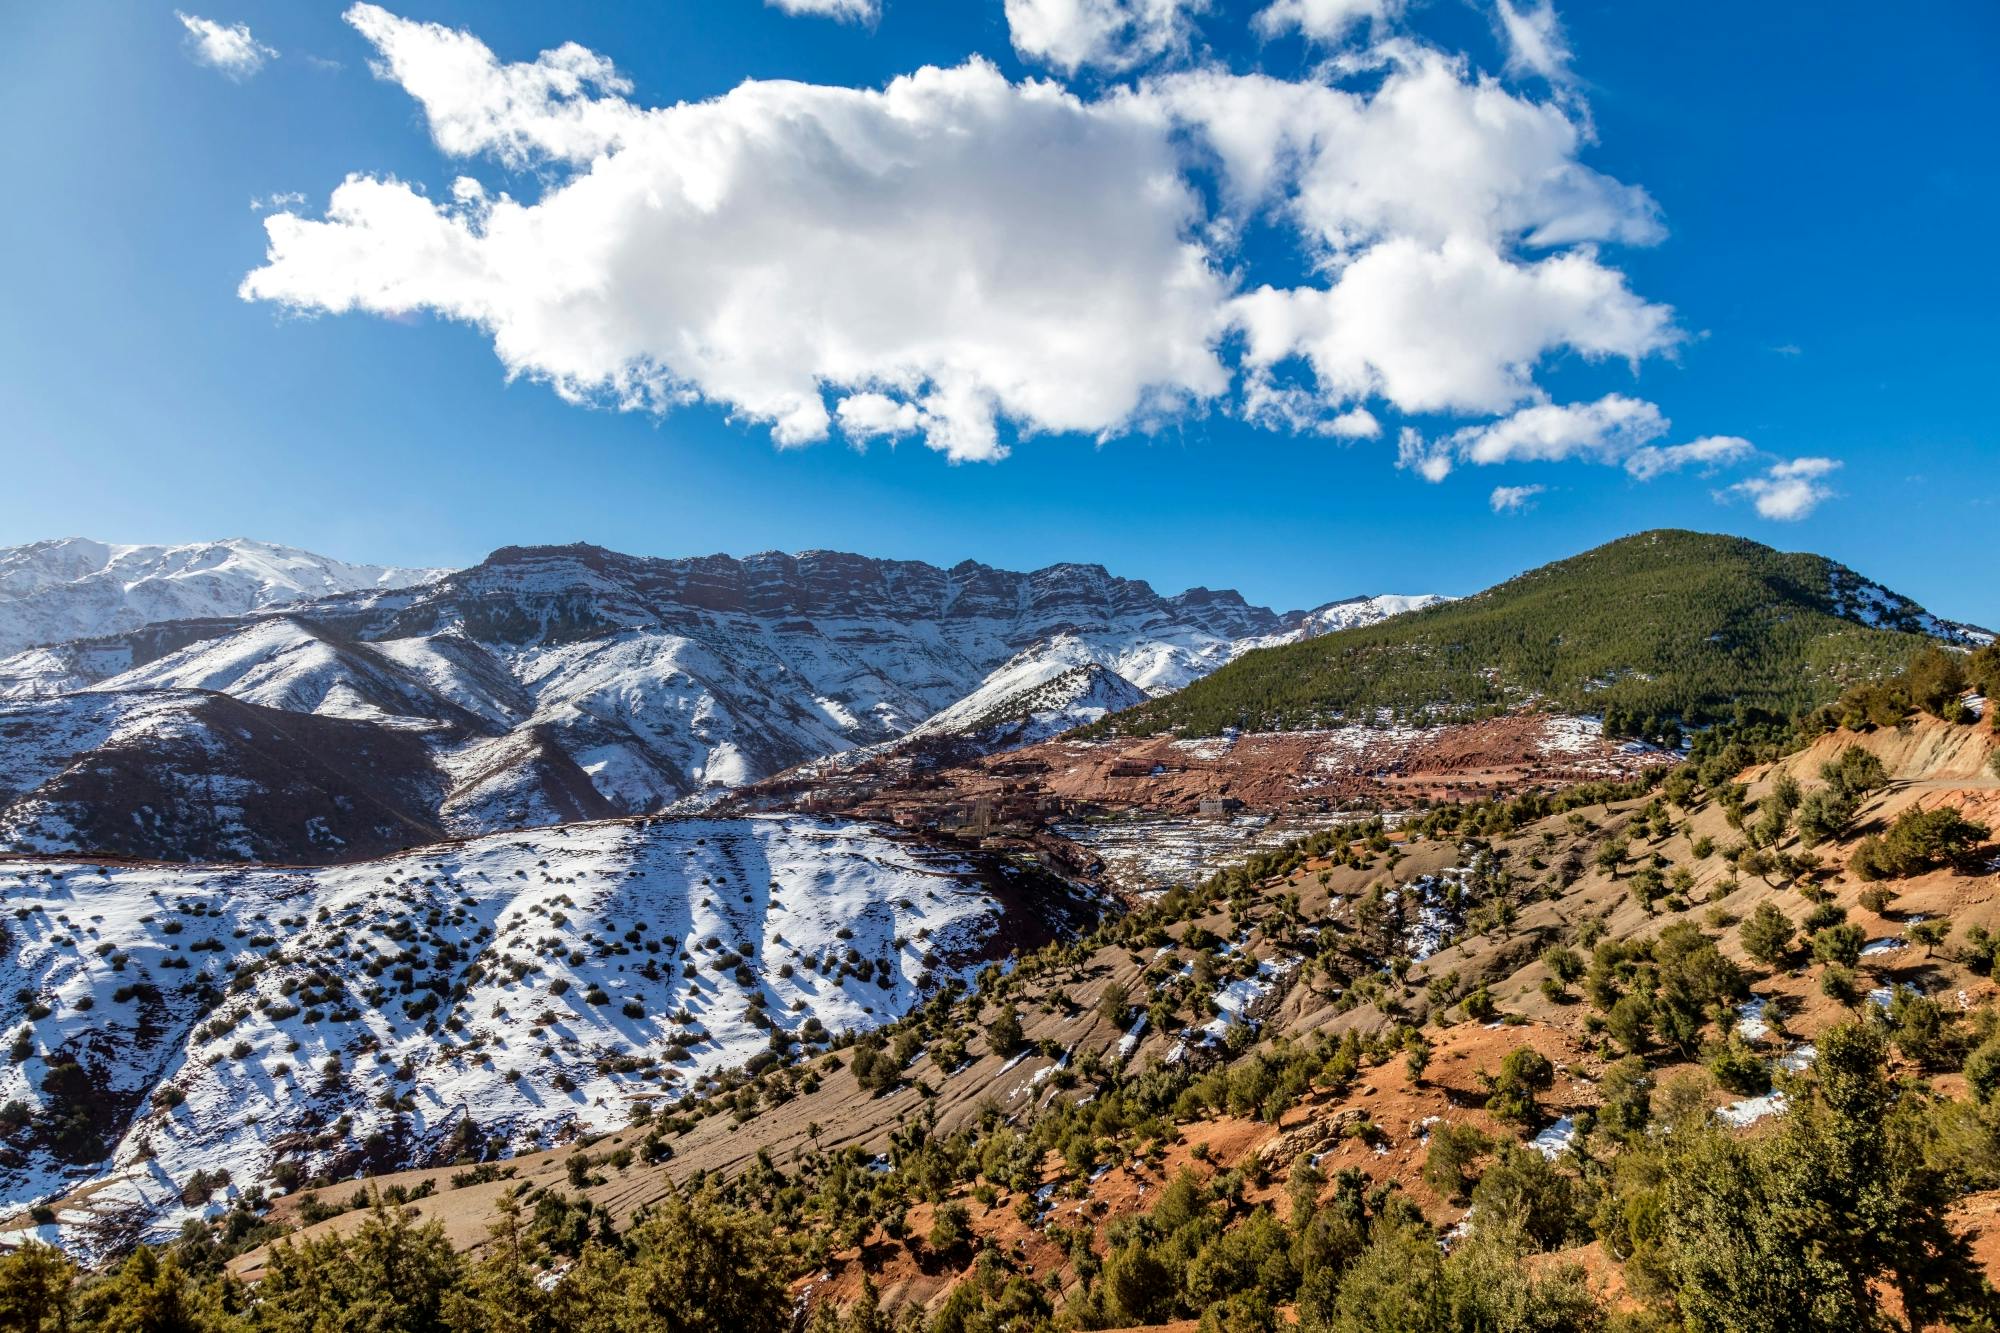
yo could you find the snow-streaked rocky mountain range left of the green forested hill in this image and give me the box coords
[0,542,1442,861]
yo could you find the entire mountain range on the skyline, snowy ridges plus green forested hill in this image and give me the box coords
[0,532,1988,863]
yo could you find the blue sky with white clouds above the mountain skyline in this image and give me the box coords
[0,0,2000,622]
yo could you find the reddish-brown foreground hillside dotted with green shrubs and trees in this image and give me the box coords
[0,673,2000,1333]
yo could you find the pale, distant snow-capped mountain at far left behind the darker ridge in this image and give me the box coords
[0,536,442,656]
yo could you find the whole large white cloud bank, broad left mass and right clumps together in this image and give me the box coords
[240,0,1680,464]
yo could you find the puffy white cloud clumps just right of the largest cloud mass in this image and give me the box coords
[1146,44,1680,420]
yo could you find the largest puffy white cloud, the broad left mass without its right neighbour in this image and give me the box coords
[242,6,1228,458]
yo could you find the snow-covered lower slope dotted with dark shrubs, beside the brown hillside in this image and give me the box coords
[0,819,1032,1249]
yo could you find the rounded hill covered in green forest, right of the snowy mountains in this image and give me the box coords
[1094,530,1936,735]
